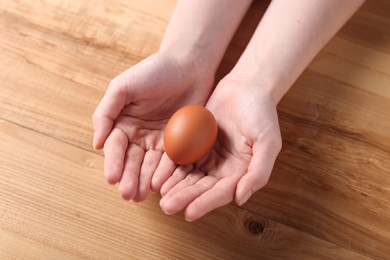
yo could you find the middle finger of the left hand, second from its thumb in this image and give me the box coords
[119,144,145,200]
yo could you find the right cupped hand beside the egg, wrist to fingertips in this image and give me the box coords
[155,76,281,221]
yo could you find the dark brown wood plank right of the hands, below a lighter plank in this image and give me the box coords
[244,72,390,258]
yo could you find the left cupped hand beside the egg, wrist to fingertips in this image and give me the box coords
[92,52,213,201]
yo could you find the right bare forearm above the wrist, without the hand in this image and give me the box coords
[232,0,364,102]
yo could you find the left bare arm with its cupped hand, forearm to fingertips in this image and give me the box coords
[92,0,250,201]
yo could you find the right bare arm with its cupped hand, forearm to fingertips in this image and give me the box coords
[160,0,363,221]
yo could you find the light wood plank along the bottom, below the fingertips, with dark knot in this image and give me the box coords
[0,120,366,259]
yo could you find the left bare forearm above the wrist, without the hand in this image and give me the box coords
[160,0,252,72]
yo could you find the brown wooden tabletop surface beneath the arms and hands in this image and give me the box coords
[0,0,390,259]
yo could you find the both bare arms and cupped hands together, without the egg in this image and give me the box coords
[93,0,363,221]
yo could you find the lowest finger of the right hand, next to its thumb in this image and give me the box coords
[184,176,239,222]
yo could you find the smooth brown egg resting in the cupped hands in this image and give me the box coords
[164,105,217,164]
